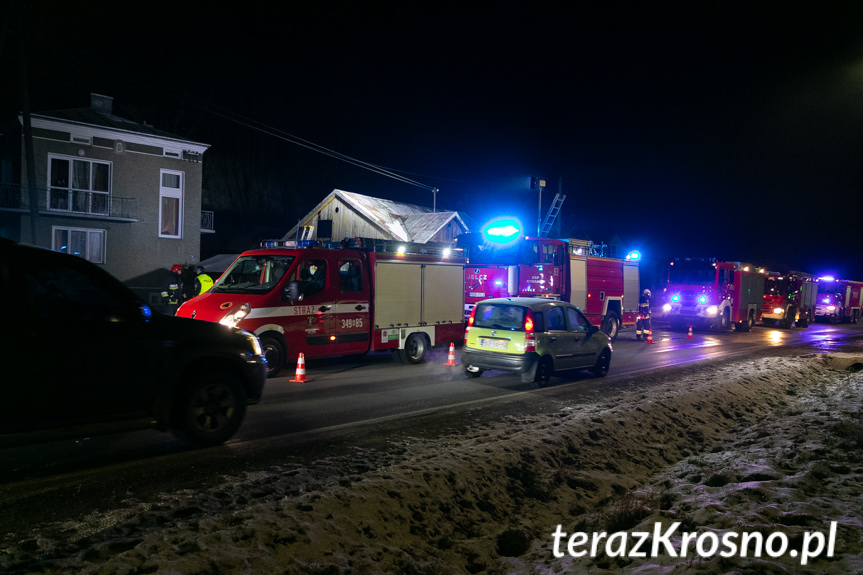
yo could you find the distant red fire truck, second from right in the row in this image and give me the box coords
[761,272,818,328]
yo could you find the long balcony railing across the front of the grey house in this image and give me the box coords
[0,184,138,221]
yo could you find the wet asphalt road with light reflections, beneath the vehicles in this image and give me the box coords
[0,324,863,533]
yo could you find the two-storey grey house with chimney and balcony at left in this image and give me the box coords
[0,94,213,307]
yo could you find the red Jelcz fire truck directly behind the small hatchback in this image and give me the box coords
[455,233,639,340]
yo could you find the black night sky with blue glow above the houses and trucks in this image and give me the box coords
[0,1,863,280]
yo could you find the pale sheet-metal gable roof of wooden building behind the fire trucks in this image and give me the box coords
[283,190,469,244]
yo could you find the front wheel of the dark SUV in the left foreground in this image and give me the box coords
[171,372,246,447]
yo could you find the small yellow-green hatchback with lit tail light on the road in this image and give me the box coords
[461,297,612,386]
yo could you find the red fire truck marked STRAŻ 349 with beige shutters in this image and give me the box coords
[177,238,464,376]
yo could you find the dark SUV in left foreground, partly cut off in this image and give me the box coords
[0,238,266,446]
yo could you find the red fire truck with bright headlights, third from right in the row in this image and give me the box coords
[662,258,764,331]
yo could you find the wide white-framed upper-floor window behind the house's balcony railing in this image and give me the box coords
[48,155,111,216]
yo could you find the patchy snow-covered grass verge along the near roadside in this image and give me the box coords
[0,354,863,574]
